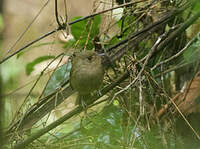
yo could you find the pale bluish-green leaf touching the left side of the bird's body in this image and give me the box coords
[43,63,71,96]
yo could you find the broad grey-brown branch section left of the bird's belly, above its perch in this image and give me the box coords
[7,82,75,134]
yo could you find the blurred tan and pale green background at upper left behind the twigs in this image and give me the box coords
[0,0,97,124]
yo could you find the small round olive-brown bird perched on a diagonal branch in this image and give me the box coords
[70,51,104,107]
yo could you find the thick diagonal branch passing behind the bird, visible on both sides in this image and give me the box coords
[7,2,188,134]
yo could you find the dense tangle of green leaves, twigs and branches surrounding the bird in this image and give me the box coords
[1,0,200,149]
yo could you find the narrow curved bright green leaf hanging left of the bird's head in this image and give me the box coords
[26,56,55,75]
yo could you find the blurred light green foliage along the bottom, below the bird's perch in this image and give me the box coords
[35,105,179,149]
